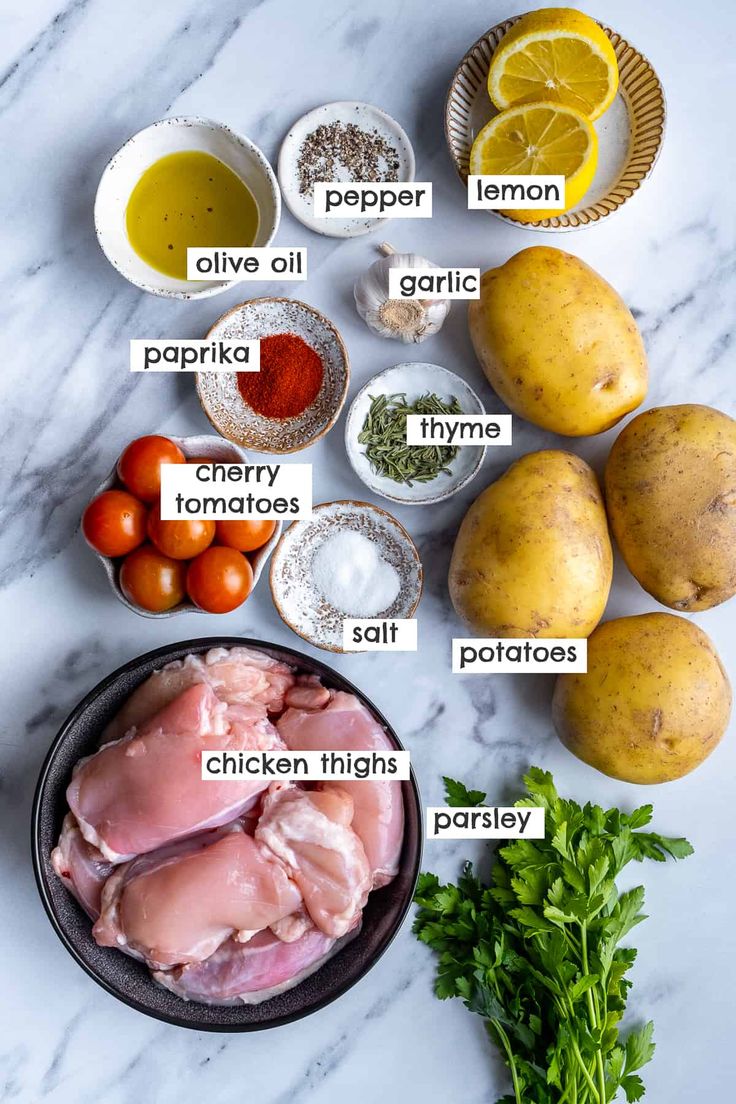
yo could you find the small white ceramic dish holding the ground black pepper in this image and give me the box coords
[278,99,416,237]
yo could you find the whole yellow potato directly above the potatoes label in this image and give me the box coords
[449,449,612,637]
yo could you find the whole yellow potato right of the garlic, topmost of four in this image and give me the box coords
[468,245,647,437]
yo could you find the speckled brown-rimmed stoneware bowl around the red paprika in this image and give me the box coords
[196,297,350,453]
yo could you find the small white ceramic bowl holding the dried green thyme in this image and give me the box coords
[345,362,486,506]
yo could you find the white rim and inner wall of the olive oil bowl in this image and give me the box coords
[94,115,281,299]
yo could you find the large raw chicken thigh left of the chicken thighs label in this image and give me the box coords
[66,683,284,862]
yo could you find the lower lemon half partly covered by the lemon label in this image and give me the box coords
[469,104,598,222]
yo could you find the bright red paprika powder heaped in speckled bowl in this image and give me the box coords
[237,333,324,418]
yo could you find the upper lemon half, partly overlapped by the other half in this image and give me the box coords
[488,8,618,119]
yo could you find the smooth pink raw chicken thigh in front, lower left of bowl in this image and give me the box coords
[93,825,301,967]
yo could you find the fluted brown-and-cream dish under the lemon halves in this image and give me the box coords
[445,15,665,233]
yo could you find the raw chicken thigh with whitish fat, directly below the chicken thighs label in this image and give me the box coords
[256,783,371,938]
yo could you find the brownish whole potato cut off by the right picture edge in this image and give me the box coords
[606,404,736,612]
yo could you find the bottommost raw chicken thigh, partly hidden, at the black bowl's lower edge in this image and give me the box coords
[153,926,337,1005]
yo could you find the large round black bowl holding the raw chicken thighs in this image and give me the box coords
[31,637,422,1031]
